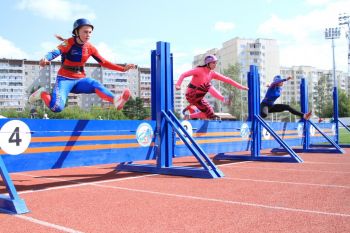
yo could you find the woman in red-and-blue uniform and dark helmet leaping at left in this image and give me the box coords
[29,19,136,112]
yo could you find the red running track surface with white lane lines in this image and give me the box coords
[0,149,350,233]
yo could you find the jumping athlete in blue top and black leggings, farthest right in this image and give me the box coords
[260,75,312,120]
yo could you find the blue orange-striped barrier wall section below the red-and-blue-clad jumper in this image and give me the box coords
[0,119,155,172]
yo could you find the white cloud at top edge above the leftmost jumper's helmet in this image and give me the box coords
[17,0,96,21]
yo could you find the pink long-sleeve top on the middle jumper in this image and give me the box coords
[176,67,244,89]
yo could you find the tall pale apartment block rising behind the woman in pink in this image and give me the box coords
[175,37,280,117]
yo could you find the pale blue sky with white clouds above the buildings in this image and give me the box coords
[0,0,350,75]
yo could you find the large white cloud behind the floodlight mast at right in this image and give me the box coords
[258,0,350,71]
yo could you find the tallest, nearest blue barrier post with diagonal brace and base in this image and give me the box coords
[117,42,224,178]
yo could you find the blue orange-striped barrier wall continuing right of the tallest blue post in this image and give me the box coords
[175,120,334,156]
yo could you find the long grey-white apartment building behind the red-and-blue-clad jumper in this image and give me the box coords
[0,58,151,111]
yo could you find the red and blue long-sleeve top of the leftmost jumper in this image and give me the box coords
[45,37,124,79]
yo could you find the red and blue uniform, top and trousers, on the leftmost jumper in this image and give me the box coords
[45,37,124,112]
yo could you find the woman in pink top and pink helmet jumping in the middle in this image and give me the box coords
[175,55,248,119]
